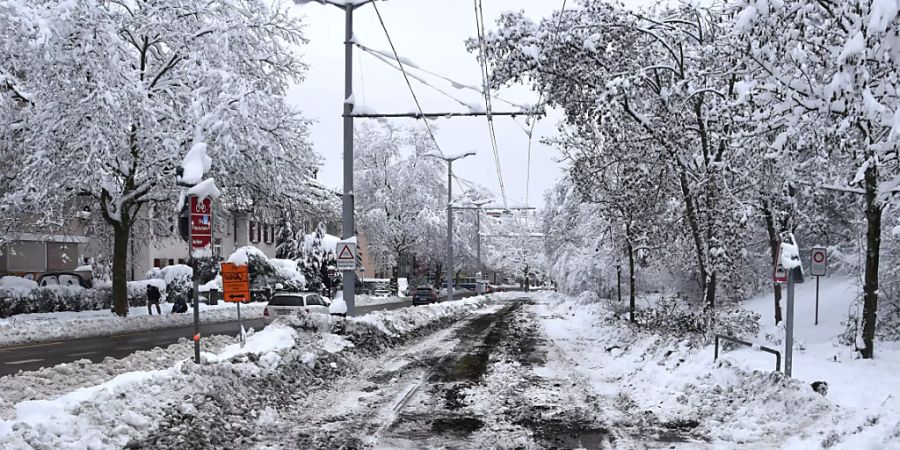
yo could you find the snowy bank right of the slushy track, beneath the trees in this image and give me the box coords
[535,279,900,449]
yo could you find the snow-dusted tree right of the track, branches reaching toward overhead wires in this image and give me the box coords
[474,1,747,308]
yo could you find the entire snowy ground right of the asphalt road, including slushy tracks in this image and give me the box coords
[0,288,900,449]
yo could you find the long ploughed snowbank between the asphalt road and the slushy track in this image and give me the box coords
[0,297,486,449]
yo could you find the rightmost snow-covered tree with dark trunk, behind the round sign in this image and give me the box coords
[735,0,900,358]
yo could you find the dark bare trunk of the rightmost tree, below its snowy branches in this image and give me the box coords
[862,164,882,359]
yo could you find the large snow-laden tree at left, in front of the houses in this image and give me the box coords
[0,0,318,315]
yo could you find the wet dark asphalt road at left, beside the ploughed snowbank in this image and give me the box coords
[0,300,412,376]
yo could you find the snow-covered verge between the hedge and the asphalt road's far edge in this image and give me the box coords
[0,302,265,347]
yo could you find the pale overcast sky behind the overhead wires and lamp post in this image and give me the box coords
[289,0,574,206]
